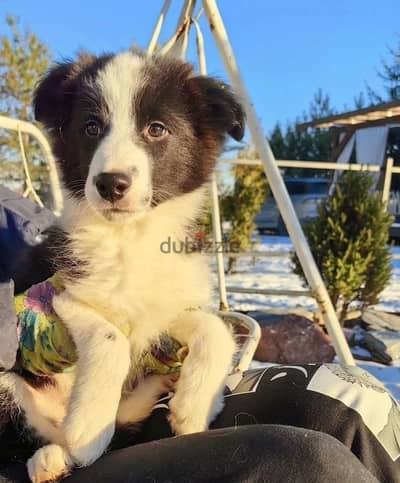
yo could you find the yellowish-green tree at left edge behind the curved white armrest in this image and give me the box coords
[0,16,50,195]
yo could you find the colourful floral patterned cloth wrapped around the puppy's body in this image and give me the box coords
[14,274,187,376]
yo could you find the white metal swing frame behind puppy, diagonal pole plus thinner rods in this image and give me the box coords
[148,0,355,365]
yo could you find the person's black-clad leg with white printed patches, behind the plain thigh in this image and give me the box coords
[114,364,400,482]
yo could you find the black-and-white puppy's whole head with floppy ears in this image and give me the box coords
[34,52,244,221]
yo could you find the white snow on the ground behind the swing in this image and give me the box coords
[219,236,400,400]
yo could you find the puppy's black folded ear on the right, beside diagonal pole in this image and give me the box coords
[187,76,245,141]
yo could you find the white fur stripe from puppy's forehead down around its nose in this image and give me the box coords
[85,52,151,210]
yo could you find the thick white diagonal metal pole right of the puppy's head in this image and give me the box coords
[203,0,354,365]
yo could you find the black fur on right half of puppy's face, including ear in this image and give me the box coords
[134,57,244,206]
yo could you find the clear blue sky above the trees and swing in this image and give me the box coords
[0,0,400,132]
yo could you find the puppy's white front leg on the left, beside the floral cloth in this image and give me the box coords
[54,292,130,466]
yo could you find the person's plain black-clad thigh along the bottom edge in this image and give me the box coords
[0,425,378,483]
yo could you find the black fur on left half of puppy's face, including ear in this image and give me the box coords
[34,54,113,198]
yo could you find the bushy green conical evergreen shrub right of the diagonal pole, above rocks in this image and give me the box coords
[292,171,392,322]
